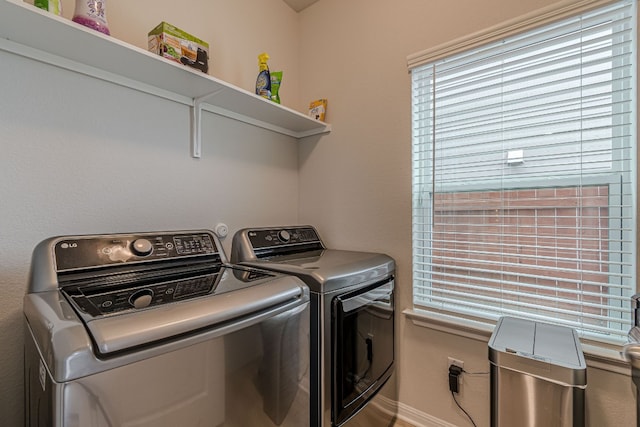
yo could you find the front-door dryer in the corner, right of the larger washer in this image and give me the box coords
[231,226,397,427]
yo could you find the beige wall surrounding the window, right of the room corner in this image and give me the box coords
[300,0,635,427]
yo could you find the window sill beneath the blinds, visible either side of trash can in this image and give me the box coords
[403,308,631,376]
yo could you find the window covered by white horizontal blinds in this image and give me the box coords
[410,1,637,342]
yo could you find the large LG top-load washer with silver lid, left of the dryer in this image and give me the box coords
[24,230,310,427]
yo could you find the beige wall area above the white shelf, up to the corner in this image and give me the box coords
[50,0,299,102]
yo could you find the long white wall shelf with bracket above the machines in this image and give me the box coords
[0,0,331,157]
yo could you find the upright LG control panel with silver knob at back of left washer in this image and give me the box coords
[54,231,220,271]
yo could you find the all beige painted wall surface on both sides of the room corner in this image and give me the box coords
[0,0,635,427]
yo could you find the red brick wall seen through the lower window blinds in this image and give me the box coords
[431,186,609,326]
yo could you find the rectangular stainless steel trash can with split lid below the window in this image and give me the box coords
[489,317,587,427]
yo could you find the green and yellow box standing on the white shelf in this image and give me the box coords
[149,21,209,73]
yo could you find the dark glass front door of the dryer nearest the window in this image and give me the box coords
[331,278,394,426]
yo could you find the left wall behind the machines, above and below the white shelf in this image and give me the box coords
[0,0,298,427]
